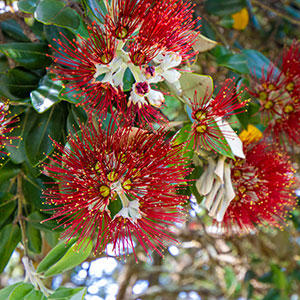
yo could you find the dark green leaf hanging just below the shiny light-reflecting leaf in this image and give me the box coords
[25,105,65,166]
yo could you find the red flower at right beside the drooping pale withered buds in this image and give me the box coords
[222,142,296,232]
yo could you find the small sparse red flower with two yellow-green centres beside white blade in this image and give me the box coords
[191,79,247,150]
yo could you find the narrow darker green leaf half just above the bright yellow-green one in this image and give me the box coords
[36,238,77,273]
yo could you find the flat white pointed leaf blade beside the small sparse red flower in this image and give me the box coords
[217,120,245,158]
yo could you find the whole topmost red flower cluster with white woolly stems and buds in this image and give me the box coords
[52,0,197,124]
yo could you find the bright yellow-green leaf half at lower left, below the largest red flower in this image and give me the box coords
[44,238,93,277]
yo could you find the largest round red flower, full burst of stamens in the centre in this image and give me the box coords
[44,124,189,255]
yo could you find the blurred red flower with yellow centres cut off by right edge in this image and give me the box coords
[251,41,300,145]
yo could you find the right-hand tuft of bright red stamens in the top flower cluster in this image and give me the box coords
[129,0,197,66]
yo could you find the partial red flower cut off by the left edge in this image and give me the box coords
[0,103,20,159]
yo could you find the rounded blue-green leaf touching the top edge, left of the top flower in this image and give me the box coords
[34,0,80,29]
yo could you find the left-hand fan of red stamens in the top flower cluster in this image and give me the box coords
[50,23,126,118]
